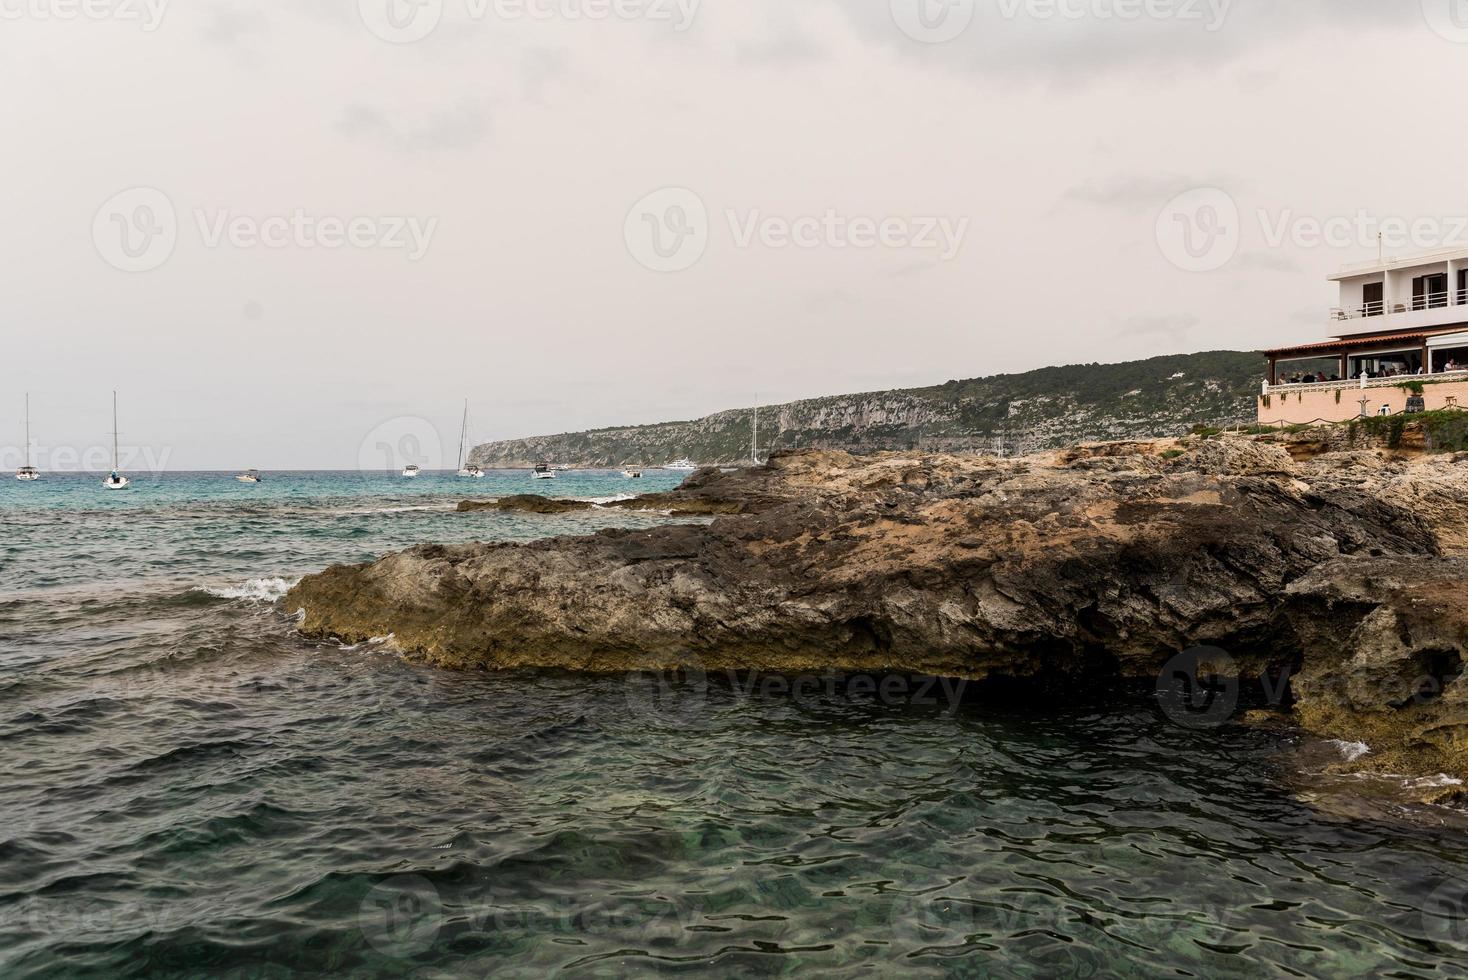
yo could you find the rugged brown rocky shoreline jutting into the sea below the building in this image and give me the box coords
[285,427,1468,798]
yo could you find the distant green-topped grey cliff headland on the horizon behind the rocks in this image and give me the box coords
[473,351,1264,467]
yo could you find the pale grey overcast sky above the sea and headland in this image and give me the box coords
[0,0,1468,469]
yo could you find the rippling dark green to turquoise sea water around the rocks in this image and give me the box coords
[0,472,1468,977]
